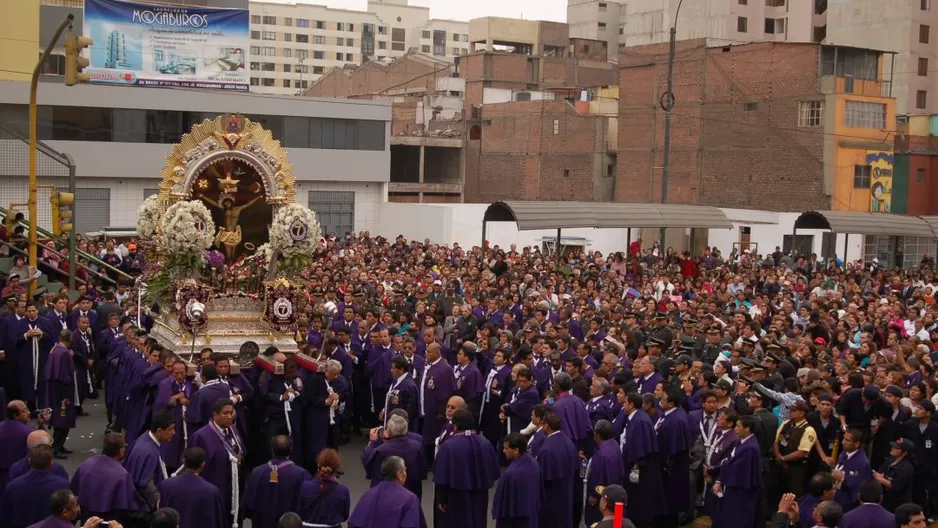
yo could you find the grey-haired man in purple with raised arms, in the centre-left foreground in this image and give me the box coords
[362,414,427,499]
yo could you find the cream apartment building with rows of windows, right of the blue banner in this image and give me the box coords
[249,0,469,95]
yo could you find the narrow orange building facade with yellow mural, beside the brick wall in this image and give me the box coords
[821,46,896,213]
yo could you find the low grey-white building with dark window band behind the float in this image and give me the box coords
[0,81,391,234]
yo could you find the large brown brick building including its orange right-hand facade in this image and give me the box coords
[615,39,895,211]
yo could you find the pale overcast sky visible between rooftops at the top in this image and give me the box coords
[275,0,567,22]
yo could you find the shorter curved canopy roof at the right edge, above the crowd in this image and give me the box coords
[795,211,938,238]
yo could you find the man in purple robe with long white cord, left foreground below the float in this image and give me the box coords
[189,398,245,526]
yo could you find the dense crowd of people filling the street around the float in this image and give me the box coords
[0,233,938,528]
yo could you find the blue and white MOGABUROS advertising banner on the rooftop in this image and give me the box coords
[83,0,250,91]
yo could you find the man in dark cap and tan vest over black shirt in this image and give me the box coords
[773,400,817,497]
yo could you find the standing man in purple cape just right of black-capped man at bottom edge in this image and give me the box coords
[619,387,668,528]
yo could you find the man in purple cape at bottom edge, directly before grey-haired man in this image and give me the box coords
[348,456,428,528]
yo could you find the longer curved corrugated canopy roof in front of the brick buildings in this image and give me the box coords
[484,201,733,231]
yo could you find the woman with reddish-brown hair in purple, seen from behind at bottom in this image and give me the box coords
[296,449,352,526]
